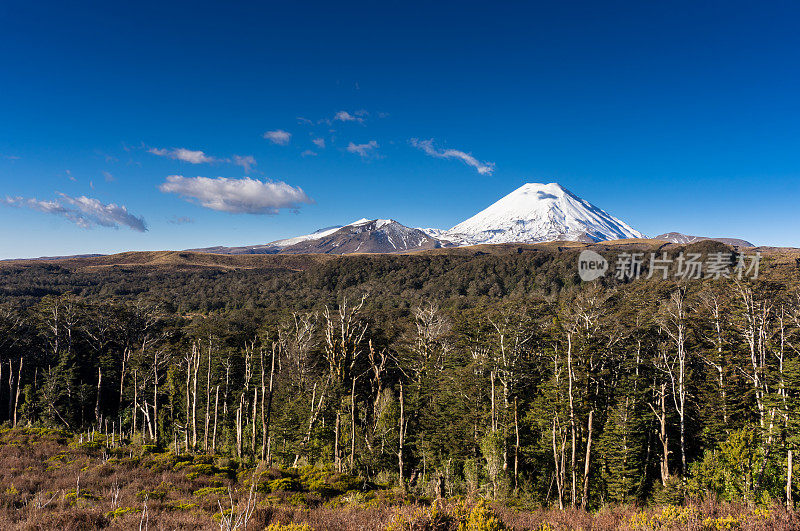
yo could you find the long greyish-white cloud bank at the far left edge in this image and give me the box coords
[0,194,147,232]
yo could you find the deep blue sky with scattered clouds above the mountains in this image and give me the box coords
[0,1,800,258]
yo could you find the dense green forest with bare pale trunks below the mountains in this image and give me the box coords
[0,244,800,509]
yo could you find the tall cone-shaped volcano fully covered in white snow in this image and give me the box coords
[440,183,643,245]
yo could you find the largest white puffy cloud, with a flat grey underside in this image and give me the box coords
[158,175,313,214]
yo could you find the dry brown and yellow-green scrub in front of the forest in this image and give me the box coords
[0,428,800,531]
